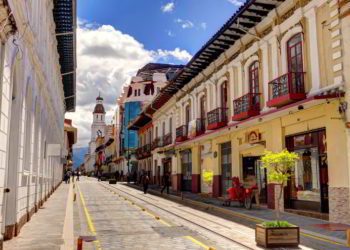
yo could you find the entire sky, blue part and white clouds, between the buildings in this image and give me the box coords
[66,0,242,147]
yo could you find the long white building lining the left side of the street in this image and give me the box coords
[0,0,76,244]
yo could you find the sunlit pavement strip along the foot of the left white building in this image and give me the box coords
[4,183,73,250]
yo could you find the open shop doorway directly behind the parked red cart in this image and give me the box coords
[243,156,267,204]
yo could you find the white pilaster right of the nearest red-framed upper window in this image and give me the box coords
[305,7,320,95]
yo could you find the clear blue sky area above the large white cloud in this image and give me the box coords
[78,0,243,55]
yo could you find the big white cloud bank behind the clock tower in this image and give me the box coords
[66,21,191,147]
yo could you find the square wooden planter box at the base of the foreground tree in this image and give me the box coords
[255,224,300,248]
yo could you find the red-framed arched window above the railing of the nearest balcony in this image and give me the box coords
[287,33,303,72]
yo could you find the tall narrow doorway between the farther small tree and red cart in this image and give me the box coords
[220,142,232,195]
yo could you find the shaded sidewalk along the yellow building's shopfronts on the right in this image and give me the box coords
[131,185,350,245]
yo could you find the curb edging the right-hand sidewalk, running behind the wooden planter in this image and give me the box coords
[127,184,347,246]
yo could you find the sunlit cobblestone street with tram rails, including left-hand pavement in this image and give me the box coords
[4,177,348,250]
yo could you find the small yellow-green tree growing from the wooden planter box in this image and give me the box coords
[261,149,299,223]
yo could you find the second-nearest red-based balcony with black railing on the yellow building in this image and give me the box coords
[232,93,260,121]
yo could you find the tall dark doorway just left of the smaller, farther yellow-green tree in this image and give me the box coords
[181,150,192,192]
